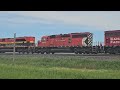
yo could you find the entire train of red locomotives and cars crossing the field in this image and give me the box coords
[0,30,120,54]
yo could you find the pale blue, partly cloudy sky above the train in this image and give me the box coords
[0,11,120,42]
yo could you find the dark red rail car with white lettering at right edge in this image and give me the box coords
[104,30,120,54]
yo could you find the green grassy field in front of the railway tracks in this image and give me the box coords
[0,55,120,79]
